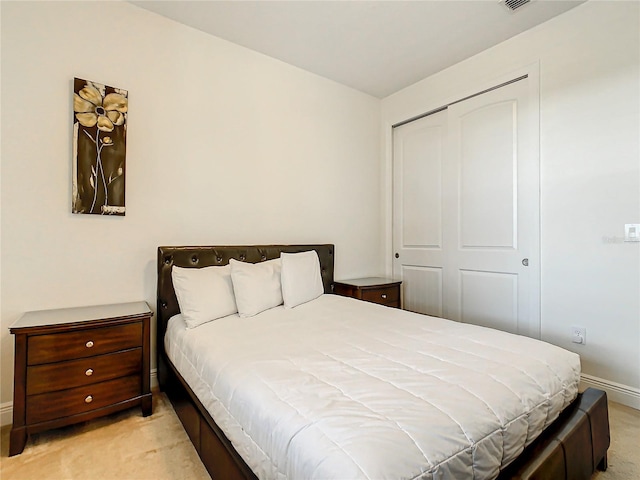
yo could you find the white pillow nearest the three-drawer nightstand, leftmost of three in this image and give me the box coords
[171,265,238,328]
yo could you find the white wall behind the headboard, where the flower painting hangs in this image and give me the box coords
[0,2,384,420]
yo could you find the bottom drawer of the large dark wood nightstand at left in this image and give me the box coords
[27,375,142,424]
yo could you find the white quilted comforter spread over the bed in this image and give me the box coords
[165,295,580,480]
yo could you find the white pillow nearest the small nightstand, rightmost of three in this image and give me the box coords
[280,250,324,308]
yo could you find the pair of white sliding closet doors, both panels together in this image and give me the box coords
[394,79,539,337]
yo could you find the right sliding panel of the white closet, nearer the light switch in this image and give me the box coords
[443,80,540,337]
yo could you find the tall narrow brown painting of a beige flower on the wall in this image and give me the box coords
[73,78,129,215]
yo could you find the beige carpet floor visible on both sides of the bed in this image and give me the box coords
[0,393,640,480]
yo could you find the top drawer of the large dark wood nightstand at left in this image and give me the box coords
[27,323,142,365]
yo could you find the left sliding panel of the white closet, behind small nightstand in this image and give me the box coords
[393,111,447,316]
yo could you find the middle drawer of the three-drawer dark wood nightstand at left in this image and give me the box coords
[27,347,142,395]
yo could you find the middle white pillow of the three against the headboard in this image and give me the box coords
[229,258,282,317]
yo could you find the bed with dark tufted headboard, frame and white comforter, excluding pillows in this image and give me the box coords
[157,245,609,479]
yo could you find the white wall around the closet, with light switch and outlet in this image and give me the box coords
[382,1,640,408]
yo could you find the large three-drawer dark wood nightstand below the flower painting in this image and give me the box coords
[9,302,152,456]
